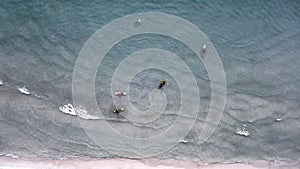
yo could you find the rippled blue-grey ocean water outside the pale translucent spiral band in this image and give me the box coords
[0,0,300,168]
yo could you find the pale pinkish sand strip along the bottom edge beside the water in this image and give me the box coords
[0,157,266,169]
